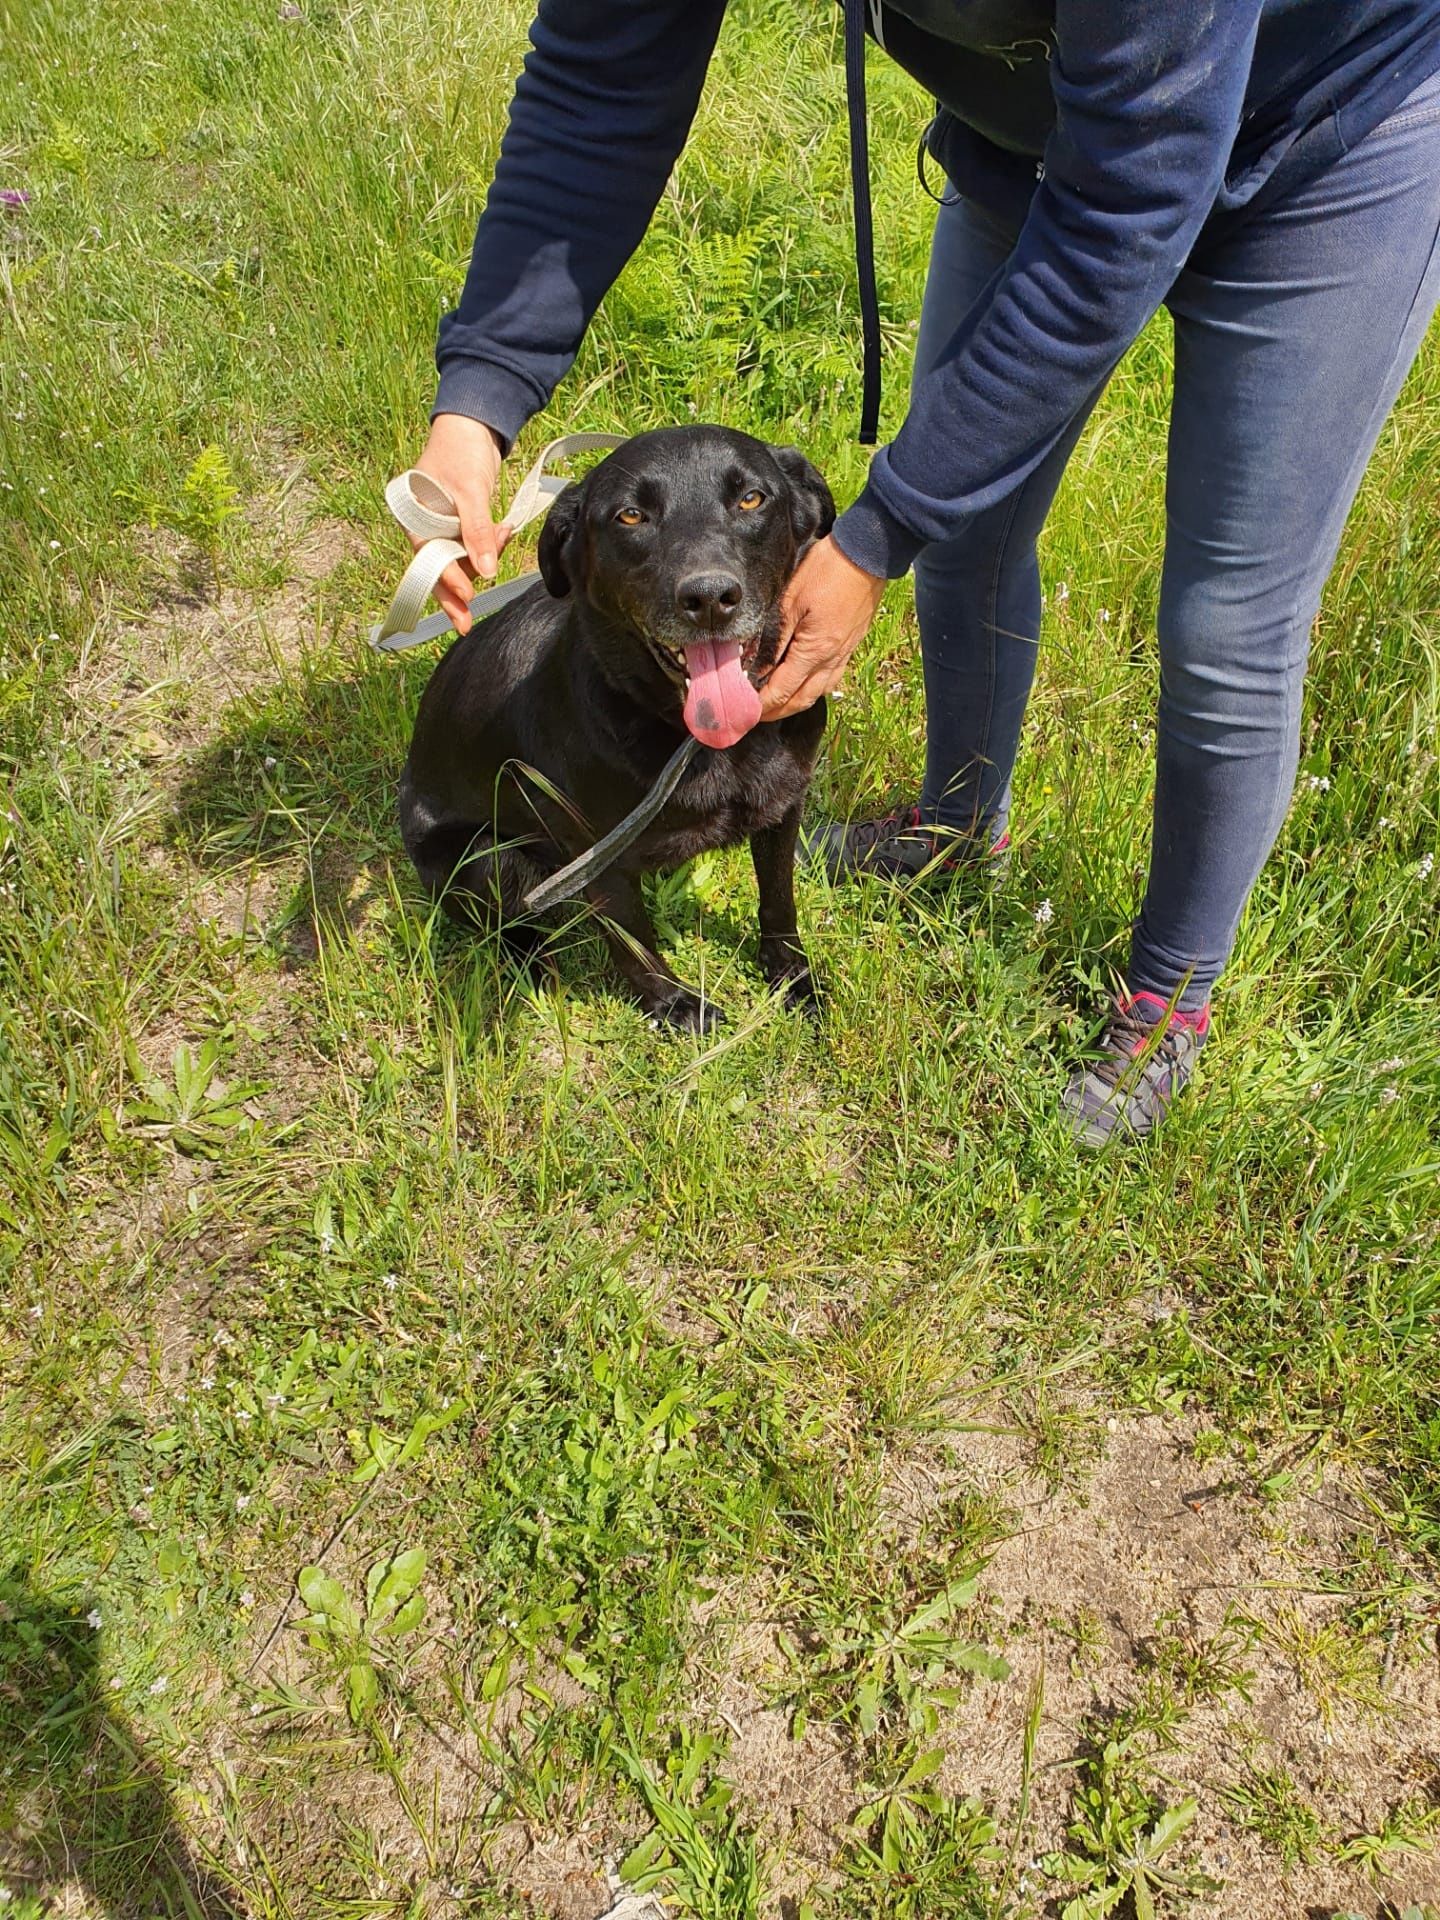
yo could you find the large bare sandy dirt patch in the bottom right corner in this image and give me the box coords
[945,1419,1440,1920]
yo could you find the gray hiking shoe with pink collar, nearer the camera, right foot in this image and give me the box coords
[1062,993,1210,1146]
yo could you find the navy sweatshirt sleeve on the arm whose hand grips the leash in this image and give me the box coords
[434,0,726,445]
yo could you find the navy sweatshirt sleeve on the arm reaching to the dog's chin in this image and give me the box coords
[835,0,1260,578]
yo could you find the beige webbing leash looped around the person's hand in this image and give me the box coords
[371,434,624,653]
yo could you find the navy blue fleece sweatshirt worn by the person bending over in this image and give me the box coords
[436,0,1440,576]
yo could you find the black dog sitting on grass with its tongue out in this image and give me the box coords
[399,426,835,1029]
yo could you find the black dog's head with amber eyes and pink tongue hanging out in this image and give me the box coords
[540,426,835,747]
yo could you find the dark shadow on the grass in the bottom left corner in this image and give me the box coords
[0,1571,246,1920]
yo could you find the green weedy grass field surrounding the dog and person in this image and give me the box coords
[0,0,1440,1920]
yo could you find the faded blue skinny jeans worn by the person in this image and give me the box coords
[914,75,1440,1008]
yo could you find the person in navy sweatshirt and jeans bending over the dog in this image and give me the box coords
[407,0,1440,1144]
